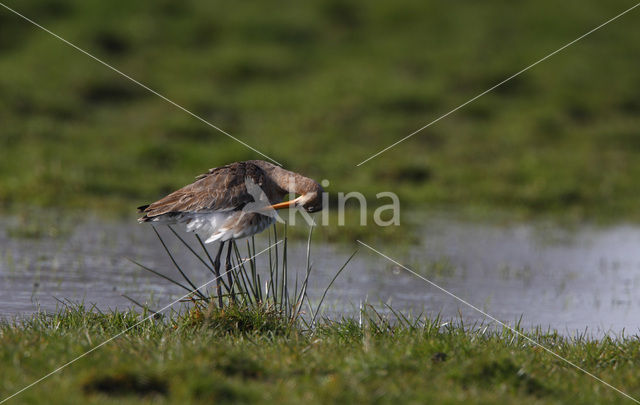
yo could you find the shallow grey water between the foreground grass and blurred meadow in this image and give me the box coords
[0,217,640,336]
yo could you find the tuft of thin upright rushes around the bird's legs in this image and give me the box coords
[127,225,357,335]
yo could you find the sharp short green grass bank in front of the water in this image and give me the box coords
[0,307,640,404]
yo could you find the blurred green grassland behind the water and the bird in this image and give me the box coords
[0,0,640,220]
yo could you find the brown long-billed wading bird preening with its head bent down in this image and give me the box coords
[138,160,324,305]
